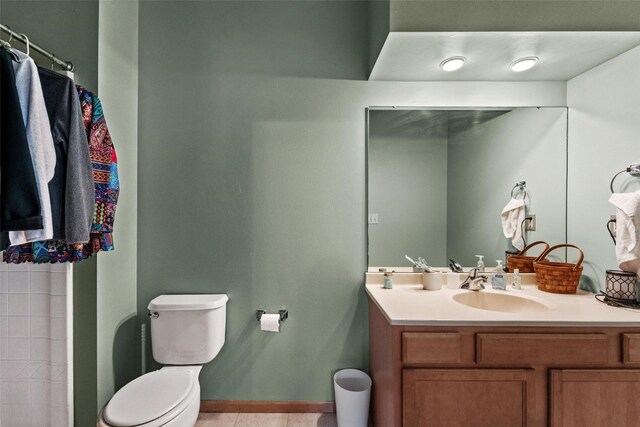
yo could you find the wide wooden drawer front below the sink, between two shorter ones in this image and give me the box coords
[476,334,609,366]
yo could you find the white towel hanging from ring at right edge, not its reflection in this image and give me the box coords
[609,191,640,274]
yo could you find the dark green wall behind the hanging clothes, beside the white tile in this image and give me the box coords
[0,0,98,426]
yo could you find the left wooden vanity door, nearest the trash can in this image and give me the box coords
[402,369,535,427]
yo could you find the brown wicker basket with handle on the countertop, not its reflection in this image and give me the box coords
[533,244,584,294]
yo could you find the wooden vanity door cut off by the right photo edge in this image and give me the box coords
[549,369,640,427]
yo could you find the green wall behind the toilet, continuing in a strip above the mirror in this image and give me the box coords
[137,1,566,400]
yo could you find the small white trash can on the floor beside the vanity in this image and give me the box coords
[333,369,372,427]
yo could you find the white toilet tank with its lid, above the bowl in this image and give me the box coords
[147,294,229,365]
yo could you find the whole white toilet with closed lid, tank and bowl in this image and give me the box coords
[97,294,229,427]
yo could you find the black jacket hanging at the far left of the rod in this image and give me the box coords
[0,48,43,249]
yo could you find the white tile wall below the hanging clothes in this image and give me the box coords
[0,263,73,427]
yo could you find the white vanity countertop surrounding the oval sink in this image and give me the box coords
[366,283,640,327]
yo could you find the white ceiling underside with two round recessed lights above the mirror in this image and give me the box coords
[369,31,640,81]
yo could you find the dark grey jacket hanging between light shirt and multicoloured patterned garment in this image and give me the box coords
[38,68,94,243]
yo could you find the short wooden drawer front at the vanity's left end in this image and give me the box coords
[402,332,462,363]
